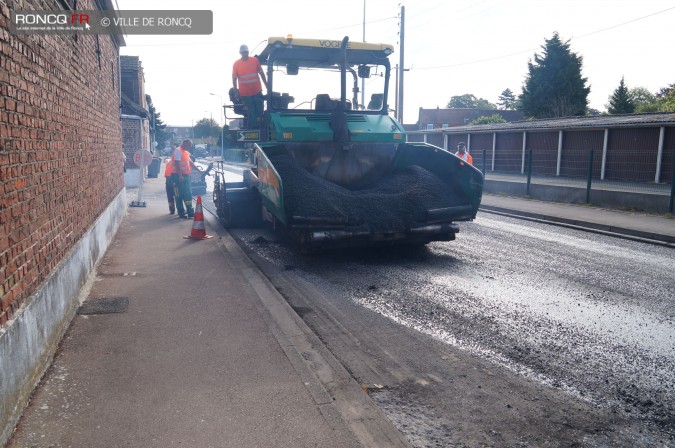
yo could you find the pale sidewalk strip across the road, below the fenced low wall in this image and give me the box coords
[481,193,675,247]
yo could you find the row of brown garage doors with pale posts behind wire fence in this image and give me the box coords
[408,126,675,212]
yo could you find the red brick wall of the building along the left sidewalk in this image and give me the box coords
[0,0,124,325]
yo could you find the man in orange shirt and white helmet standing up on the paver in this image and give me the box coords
[232,45,268,129]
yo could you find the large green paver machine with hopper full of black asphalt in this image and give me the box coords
[214,36,483,250]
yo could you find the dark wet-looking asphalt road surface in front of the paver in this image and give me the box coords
[202,163,675,446]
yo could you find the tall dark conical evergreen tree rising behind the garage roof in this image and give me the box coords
[520,32,591,118]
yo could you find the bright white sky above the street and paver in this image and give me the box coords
[114,0,675,126]
